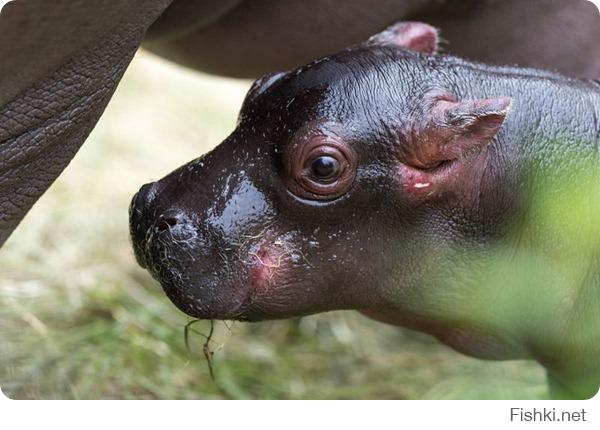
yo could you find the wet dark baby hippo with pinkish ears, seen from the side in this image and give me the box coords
[130,23,600,398]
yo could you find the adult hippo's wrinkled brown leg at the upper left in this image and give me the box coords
[0,0,171,245]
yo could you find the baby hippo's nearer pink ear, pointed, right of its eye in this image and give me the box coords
[404,96,512,169]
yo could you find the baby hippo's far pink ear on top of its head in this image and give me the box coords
[367,22,440,54]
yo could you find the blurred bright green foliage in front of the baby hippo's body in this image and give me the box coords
[413,152,600,398]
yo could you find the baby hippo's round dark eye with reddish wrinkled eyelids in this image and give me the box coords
[286,135,356,200]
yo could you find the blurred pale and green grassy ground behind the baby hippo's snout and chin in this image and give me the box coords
[0,53,546,399]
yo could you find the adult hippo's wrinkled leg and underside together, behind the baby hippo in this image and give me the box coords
[0,0,600,245]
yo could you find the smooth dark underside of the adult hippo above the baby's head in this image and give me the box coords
[145,0,600,78]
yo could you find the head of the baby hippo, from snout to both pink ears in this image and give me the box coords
[130,24,510,320]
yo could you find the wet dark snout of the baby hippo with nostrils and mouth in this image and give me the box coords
[129,163,270,319]
